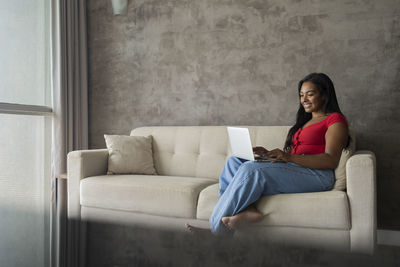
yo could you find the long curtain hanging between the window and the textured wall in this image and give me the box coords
[51,0,88,267]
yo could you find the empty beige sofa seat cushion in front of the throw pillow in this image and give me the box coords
[80,175,215,218]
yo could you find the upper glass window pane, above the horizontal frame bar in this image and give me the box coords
[0,0,50,106]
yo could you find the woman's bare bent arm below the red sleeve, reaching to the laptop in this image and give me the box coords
[267,122,348,169]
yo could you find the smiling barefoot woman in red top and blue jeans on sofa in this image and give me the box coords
[186,73,349,235]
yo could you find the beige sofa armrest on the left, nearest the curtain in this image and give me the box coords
[67,149,108,220]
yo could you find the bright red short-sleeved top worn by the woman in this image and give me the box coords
[291,112,348,154]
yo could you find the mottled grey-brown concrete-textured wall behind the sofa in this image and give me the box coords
[88,0,400,229]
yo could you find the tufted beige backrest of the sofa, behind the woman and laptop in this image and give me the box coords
[131,126,355,190]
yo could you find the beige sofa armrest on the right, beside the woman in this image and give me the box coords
[346,151,377,254]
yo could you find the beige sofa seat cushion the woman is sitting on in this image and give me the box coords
[197,184,351,230]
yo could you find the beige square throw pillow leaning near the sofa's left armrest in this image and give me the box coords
[104,135,157,174]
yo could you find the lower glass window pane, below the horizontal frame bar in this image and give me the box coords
[0,114,50,266]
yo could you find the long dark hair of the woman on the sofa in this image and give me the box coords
[283,73,350,153]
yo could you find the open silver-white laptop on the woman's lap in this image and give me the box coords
[227,127,274,161]
